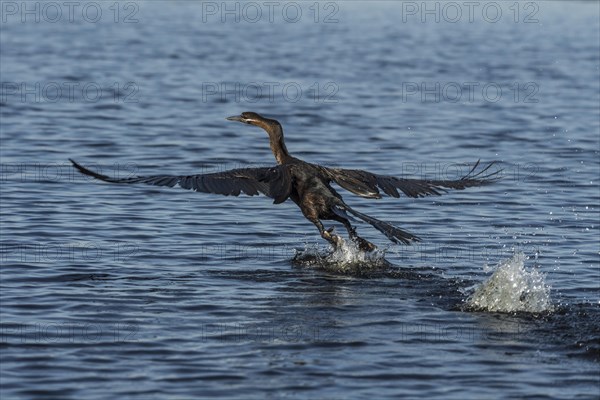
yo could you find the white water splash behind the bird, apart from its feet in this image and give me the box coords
[467,252,553,313]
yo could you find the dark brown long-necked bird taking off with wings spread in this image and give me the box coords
[70,112,500,251]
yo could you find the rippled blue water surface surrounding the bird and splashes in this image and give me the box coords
[0,1,600,399]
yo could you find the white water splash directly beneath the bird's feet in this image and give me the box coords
[292,237,391,275]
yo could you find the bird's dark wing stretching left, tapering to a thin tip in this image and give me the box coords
[69,159,292,199]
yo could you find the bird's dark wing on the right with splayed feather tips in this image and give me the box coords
[323,161,501,199]
